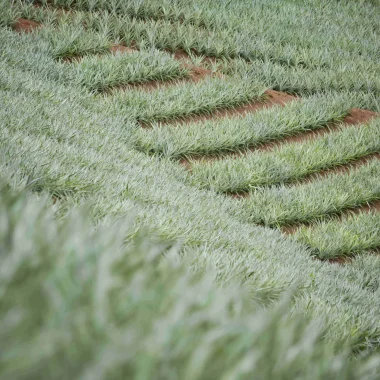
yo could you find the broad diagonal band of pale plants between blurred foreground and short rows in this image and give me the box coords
[0,52,380,354]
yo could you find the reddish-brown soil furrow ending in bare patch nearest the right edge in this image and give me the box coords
[180,107,380,166]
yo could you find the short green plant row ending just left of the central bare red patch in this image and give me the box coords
[105,77,266,123]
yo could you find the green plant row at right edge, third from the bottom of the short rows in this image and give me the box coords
[191,119,380,192]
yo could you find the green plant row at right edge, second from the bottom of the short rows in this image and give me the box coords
[241,158,380,226]
